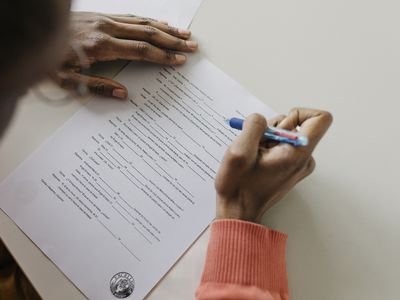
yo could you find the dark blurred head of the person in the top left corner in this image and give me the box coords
[0,0,70,136]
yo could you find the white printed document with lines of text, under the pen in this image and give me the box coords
[0,56,274,299]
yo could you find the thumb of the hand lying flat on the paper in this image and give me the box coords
[53,71,128,99]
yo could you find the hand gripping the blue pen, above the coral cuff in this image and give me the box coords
[215,108,332,222]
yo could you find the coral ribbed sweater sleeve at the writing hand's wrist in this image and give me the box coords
[196,220,289,300]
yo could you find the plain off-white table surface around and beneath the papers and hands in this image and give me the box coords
[0,0,400,300]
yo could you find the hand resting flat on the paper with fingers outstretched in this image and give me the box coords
[53,12,197,99]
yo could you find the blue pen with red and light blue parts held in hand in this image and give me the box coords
[226,118,308,147]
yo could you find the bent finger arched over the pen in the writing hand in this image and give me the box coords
[278,108,333,151]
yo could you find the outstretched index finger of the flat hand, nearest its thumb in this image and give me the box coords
[110,38,186,65]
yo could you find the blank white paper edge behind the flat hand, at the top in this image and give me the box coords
[72,0,202,28]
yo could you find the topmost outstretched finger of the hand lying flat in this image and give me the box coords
[106,15,191,39]
